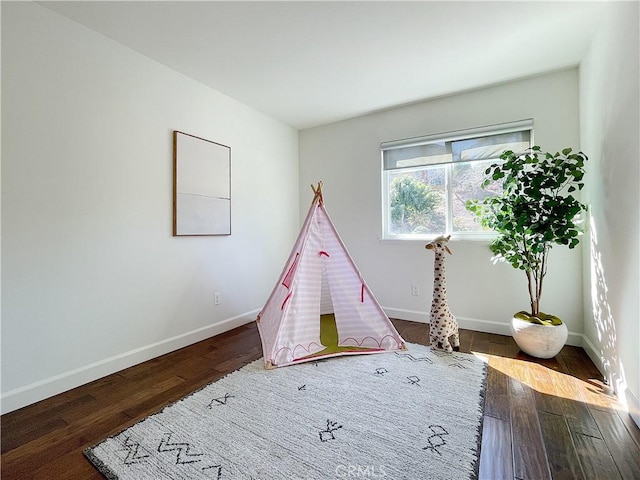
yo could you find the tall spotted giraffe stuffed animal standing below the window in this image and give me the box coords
[424,235,460,353]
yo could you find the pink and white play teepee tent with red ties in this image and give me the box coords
[256,182,405,368]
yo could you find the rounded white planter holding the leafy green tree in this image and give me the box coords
[511,317,569,358]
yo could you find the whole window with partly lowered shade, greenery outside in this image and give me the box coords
[381,120,533,239]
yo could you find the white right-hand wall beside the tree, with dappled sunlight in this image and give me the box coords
[580,2,640,426]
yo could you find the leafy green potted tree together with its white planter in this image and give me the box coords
[466,146,587,358]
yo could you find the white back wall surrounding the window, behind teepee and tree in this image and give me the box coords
[300,69,583,345]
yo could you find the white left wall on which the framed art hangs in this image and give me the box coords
[2,2,299,412]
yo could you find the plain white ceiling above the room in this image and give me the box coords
[40,1,606,129]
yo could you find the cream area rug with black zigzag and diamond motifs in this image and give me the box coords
[85,344,486,480]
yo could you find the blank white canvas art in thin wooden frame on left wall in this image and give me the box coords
[173,130,231,236]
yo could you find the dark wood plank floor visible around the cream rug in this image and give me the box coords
[1,320,640,480]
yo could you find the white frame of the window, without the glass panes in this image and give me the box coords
[380,118,535,242]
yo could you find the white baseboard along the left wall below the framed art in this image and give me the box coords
[0,310,259,414]
